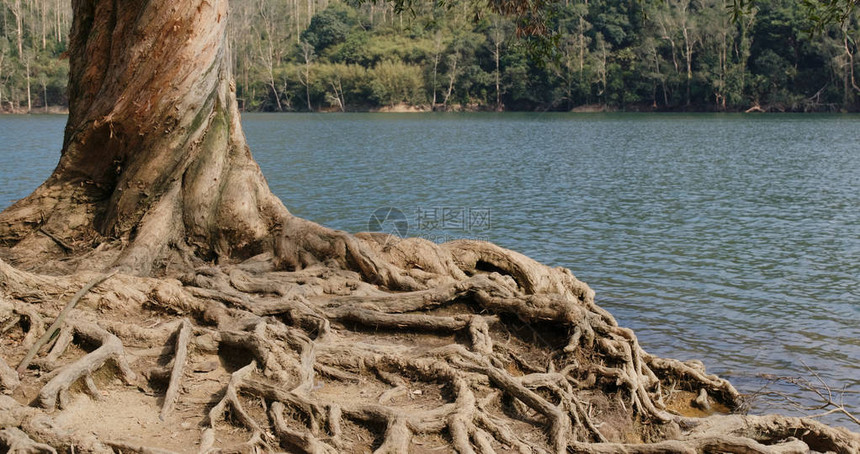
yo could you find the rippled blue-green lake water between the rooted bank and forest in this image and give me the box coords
[0,114,860,430]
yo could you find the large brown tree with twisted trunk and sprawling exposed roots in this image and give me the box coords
[0,0,860,453]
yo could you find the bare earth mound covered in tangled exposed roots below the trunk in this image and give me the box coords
[0,231,860,453]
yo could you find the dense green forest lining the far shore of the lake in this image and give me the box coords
[0,0,860,113]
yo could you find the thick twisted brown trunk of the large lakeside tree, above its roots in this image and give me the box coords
[0,0,286,274]
